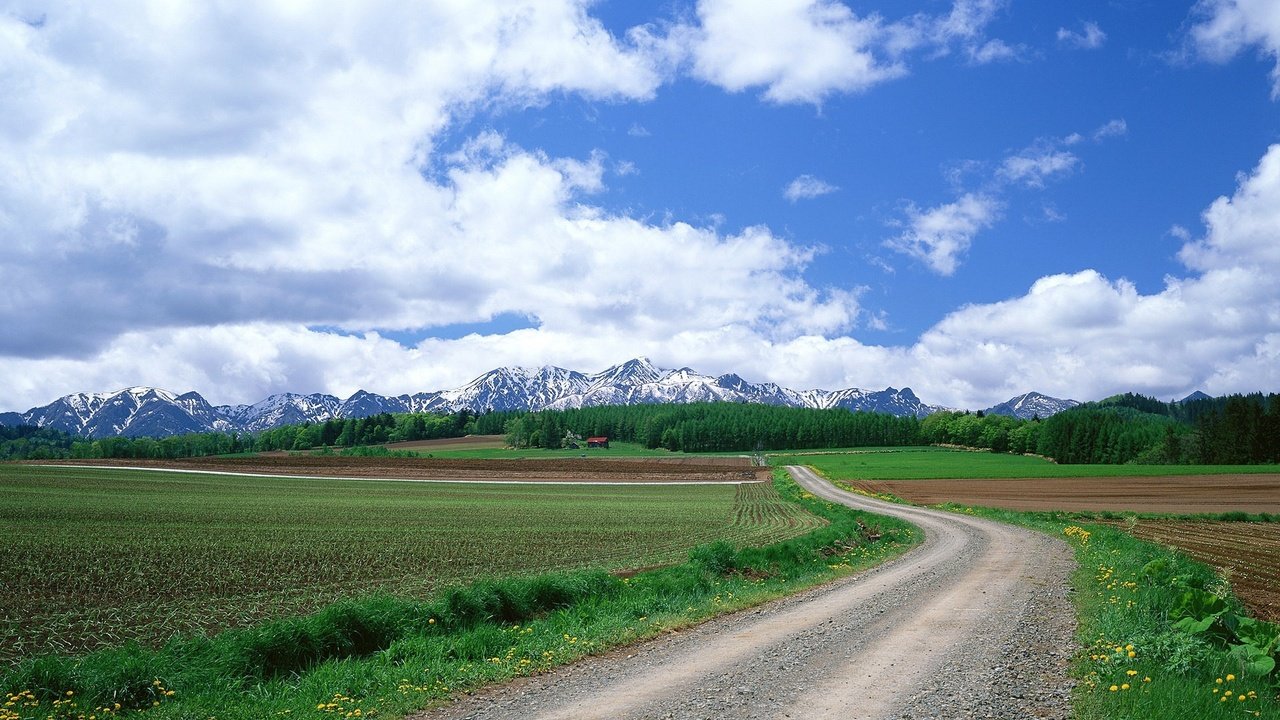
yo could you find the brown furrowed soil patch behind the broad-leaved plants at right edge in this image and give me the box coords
[1108,520,1280,621]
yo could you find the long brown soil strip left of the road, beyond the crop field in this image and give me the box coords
[47,455,771,483]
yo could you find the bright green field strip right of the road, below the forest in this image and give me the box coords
[769,447,1280,480]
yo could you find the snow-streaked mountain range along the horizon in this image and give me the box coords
[0,357,1078,438]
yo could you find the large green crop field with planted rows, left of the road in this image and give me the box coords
[0,465,824,665]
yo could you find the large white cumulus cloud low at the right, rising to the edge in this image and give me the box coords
[910,145,1280,402]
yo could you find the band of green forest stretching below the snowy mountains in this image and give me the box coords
[0,393,1280,465]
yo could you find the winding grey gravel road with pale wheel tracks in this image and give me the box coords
[419,468,1074,720]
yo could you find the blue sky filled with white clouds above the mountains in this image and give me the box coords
[0,0,1280,411]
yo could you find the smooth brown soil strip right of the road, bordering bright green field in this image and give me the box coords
[851,474,1280,514]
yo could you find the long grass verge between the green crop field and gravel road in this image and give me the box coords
[0,470,920,720]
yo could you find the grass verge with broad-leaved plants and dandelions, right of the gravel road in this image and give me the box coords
[942,505,1280,720]
